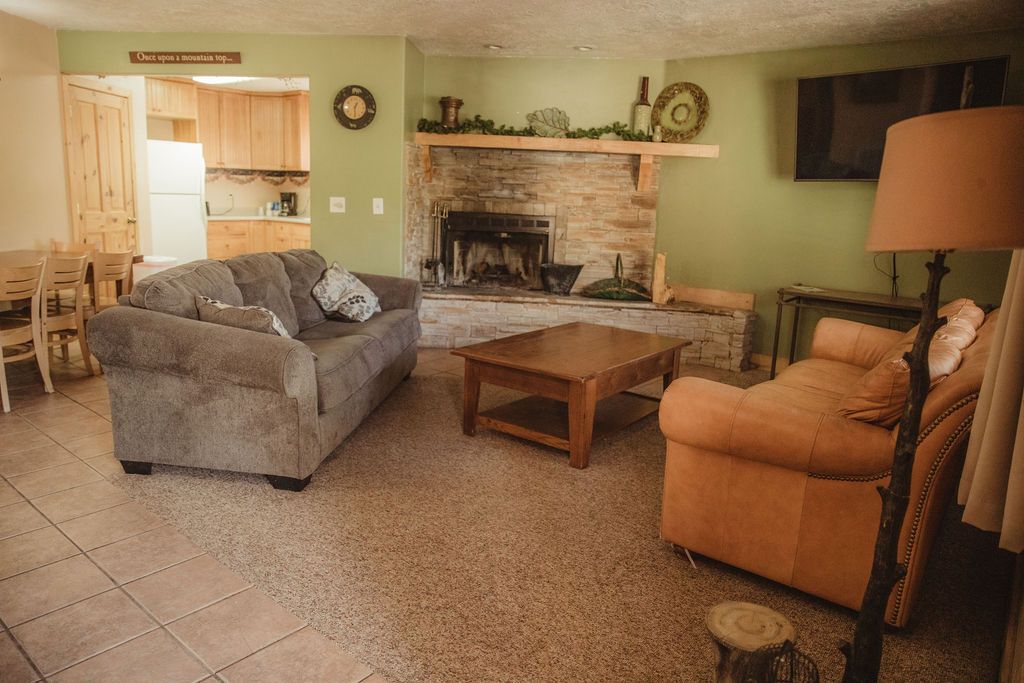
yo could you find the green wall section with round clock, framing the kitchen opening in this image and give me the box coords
[58,31,422,274]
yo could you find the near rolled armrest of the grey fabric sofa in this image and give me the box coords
[87,306,316,397]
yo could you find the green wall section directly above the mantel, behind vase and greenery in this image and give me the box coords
[423,56,666,128]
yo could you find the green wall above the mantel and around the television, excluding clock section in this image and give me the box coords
[423,31,1024,353]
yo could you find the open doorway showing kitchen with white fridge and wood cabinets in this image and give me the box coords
[58,75,311,263]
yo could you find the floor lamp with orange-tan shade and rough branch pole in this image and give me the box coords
[843,106,1024,683]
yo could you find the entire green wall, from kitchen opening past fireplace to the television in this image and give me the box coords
[58,31,1024,352]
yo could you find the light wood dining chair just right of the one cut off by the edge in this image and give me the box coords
[40,254,96,375]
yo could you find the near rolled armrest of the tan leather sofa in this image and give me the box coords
[659,377,895,477]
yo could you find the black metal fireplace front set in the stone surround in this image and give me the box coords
[441,211,555,290]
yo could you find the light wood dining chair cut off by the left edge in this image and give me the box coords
[0,258,53,413]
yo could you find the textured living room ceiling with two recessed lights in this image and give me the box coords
[0,0,1024,58]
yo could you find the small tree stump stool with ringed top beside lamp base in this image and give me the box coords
[708,602,797,683]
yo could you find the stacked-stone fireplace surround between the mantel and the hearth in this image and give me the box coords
[404,143,659,289]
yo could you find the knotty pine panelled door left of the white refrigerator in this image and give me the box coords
[63,77,138,253]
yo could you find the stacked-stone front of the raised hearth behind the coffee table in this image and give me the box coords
[420,290,757,371]
